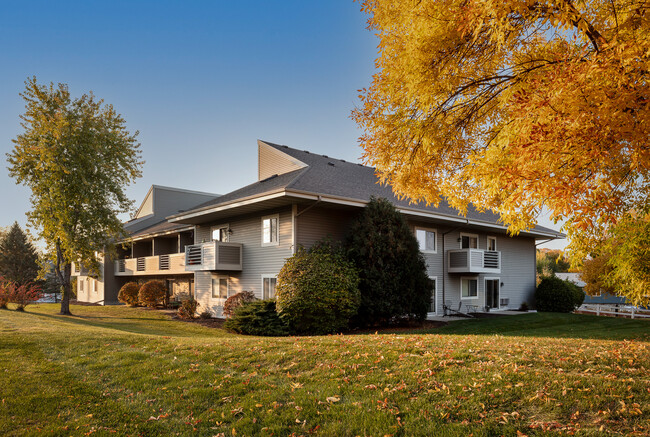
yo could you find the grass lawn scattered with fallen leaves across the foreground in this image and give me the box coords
[0,304,650,436]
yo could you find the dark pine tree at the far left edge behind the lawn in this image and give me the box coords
[0,222,40,286]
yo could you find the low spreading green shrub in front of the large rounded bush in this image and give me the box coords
[223,299,289,337]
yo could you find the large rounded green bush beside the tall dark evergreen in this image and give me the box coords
[276,243,361,334]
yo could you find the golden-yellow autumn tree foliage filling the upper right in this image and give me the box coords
[352,0,650,257]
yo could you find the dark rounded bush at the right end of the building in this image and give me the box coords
[535,276,584,313]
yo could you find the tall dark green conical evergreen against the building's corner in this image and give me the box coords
[345,198,431,325]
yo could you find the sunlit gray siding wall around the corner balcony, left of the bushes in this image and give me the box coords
[194,208,293,316]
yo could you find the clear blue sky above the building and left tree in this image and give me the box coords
[0,0,564,249]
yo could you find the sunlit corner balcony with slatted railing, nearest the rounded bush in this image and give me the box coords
[185,241,242,272]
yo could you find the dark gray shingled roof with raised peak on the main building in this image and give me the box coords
[168,140,564,238]
